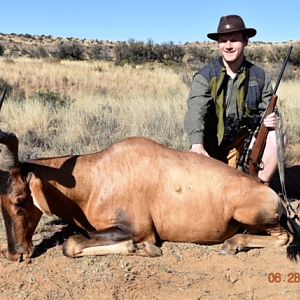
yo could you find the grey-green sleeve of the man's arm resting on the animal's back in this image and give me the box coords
[184,73,213,145]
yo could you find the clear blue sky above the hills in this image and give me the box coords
[0,0,300,43]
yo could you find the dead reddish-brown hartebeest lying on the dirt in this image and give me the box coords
[0,131,293,260]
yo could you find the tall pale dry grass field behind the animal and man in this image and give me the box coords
[0,58,300,161]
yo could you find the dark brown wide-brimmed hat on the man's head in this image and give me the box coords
[207,15,256,41]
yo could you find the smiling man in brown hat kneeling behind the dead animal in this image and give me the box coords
[184,15,277,183]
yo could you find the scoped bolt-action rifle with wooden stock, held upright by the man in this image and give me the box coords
[238,46,293,177]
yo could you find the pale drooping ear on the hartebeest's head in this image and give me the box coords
[26,172,52,216]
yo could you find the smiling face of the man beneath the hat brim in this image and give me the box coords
[219,32,248,63]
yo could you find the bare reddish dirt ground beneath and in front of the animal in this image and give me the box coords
[0,169,300,300]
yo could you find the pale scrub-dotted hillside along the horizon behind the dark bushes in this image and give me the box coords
[0,33,300,60]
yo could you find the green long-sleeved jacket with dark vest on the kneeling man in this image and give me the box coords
[184,57,273,148]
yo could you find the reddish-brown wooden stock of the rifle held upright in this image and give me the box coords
[249,95,278,177]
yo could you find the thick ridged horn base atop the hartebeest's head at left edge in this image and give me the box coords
[0,130,19,171]
